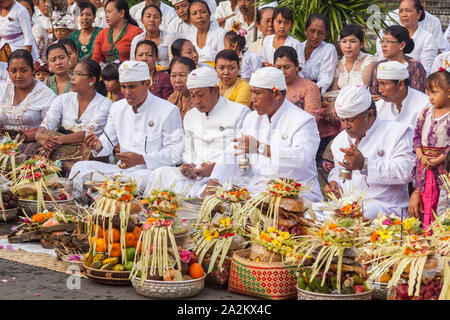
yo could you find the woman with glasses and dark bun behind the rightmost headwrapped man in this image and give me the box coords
[370,26,427,101]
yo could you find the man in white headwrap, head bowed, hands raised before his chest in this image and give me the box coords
[324,84,415,219]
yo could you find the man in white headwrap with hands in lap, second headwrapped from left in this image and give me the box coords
[146,67,250,197]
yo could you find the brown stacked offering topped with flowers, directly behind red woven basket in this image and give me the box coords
[241,178,314,235]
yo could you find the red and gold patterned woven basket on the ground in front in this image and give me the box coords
[228,249,301,300]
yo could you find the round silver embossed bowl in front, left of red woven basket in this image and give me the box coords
[131,274,206,299]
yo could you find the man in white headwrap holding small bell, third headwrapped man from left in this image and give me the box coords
[204,67,322,201]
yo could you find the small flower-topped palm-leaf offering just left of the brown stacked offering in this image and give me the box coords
[197,185,250,224]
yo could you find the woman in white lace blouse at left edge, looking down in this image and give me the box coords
[0,49,56,146]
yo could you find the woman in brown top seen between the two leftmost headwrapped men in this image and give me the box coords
[167,57,197,119]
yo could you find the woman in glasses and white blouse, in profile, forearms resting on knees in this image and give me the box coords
[36,58,112,171]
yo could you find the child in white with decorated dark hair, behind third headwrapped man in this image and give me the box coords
[224,29,262,82]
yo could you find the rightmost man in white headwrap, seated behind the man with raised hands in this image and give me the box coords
[375,61,430,130]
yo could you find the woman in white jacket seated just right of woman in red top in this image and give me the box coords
[130,5,176,69]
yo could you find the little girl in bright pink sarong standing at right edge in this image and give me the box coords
[409,68,450,229]
